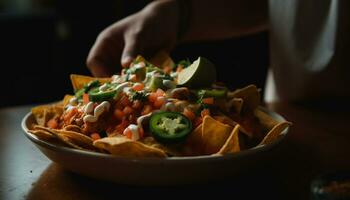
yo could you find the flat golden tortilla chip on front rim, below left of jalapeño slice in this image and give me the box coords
[93,136,167,158]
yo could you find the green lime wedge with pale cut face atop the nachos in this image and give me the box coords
[177,57,216,88]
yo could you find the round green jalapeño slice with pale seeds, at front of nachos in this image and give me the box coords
[149,112,192,143]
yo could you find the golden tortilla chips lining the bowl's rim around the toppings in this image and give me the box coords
[29,81,291,157]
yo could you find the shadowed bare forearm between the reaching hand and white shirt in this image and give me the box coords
[179,0,268,41]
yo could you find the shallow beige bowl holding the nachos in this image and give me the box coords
[22,108,288,185]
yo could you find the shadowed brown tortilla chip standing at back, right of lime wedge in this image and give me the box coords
[227,85,260,110]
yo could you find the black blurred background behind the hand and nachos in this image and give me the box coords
[0,0,268,107]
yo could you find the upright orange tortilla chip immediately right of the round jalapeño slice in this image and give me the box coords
[202,115,233,154]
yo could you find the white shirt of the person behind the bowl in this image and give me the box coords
[265,0,350,102]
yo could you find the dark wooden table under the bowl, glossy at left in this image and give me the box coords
[0,104,350,199]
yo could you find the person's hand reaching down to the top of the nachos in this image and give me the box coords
[86,0,179,77]
